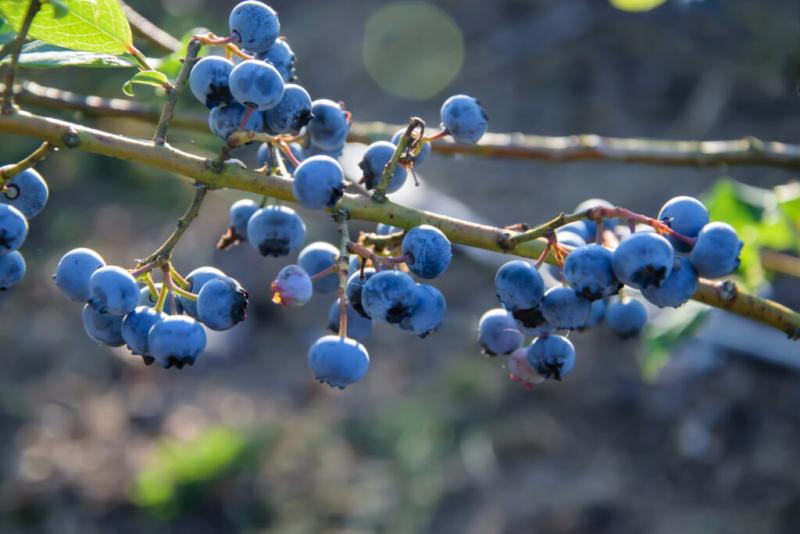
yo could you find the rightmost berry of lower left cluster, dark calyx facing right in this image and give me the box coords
[197,277,247,330]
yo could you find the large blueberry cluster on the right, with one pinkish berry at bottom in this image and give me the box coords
[478,196,742,387]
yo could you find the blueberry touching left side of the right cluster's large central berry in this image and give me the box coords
[564,245,620,300]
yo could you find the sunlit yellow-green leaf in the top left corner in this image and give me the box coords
[0,0,133,55]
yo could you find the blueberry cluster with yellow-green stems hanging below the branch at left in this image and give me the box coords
[53,248,248,369]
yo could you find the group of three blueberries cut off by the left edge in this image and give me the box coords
[0,167,49,291]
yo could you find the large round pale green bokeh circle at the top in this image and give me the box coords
[363,1,464,100]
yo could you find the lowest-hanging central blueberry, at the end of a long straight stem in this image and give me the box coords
[308,336,369,389]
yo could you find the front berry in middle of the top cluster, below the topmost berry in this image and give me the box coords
[229,59,284,111]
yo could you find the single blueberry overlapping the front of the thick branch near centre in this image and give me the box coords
[292,156,344,209]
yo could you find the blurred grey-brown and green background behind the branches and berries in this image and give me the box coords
[0,0,800,534]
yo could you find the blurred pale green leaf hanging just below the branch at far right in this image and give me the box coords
[640,301,709,381]
